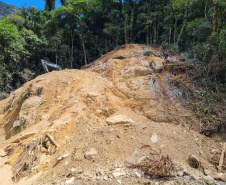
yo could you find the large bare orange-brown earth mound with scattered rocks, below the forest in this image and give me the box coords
[0,44,221,184]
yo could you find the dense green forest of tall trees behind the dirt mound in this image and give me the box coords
[0,0,226,98]
